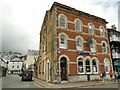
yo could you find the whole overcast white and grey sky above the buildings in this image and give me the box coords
[0,0,119,54]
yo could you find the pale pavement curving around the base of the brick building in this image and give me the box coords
[33,78,117,88]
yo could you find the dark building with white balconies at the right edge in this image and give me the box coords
[107,25,120,75]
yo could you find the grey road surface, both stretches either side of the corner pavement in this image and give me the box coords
[2,75,118,88]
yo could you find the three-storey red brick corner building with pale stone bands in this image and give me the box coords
[38,2,112,83]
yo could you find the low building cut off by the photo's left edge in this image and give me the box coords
[0,58,8,77]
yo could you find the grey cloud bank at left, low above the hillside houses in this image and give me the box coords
[2,20,32,53]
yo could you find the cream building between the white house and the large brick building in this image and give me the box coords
[25,50,38,71]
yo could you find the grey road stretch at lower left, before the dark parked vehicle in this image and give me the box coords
[2,75,42,88]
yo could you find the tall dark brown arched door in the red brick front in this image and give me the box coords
[60,57,67,80]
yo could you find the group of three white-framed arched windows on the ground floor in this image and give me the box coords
[77,57,99,74]
